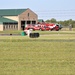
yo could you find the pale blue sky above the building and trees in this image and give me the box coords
[0,0,75,20]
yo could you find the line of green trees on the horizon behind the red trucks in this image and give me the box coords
[45,18,75,28]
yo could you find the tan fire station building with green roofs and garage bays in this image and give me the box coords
[0,8,38,31]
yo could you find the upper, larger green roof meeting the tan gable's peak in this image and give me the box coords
[0,9,27,16]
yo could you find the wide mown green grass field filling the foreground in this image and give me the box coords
[0,31,75,75]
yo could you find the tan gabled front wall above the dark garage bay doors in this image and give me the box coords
[18,9,38,30]
